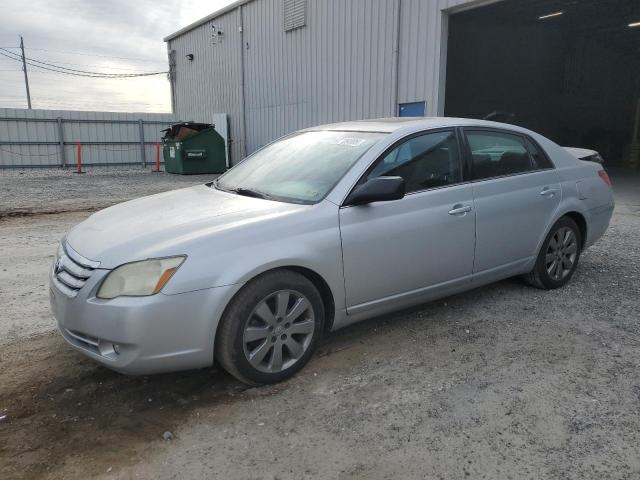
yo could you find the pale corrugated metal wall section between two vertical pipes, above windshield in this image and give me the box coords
[243,0,396,151]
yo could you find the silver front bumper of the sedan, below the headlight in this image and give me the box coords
[49,270,239,374]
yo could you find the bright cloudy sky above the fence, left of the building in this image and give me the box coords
[0,0,238,112]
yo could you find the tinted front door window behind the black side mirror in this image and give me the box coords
[367,130,462,193]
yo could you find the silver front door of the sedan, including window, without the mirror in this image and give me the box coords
[340,129,475,313]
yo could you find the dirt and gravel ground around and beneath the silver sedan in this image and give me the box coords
[0,167,640,479]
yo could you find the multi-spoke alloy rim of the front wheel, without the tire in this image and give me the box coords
[243,290,315,373]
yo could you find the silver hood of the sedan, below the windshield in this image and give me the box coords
[66,185,308,269]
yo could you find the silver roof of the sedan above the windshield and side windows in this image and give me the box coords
[306,117,523,133]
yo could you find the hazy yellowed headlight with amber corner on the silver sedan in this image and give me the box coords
[98,256,186,299]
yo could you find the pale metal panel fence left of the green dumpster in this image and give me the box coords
[0,108,177,169]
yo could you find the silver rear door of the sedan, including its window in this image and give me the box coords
[464,128,561,275]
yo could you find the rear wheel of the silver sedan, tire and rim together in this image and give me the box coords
[524,217,582,290]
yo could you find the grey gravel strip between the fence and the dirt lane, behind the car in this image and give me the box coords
[0,167,217,218]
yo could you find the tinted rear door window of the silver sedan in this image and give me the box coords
[465,130,534,180]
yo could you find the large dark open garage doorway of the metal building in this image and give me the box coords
[445,0,640,164]
